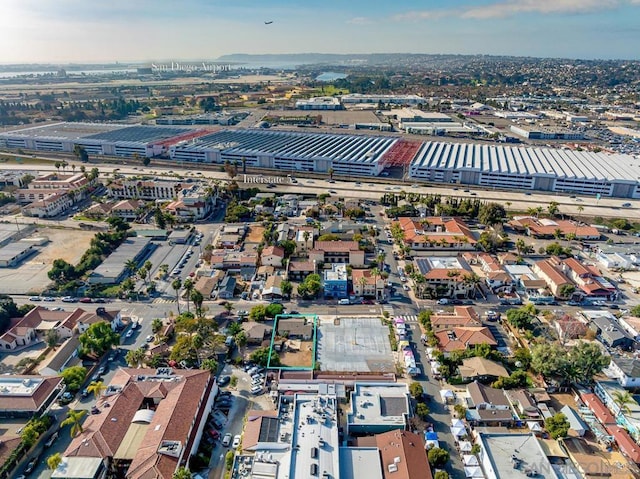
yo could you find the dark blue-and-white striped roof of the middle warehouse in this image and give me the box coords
[172,130,398,163]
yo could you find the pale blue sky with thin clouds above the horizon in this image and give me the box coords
[0,0,640,63]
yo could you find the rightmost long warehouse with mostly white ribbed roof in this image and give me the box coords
[409,142,640,198]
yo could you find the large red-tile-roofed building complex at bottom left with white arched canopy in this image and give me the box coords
[63,368,217,479]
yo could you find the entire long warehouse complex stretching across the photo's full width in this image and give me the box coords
[0,123,640,198]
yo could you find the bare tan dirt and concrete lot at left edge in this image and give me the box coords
[0,228,95,294]
